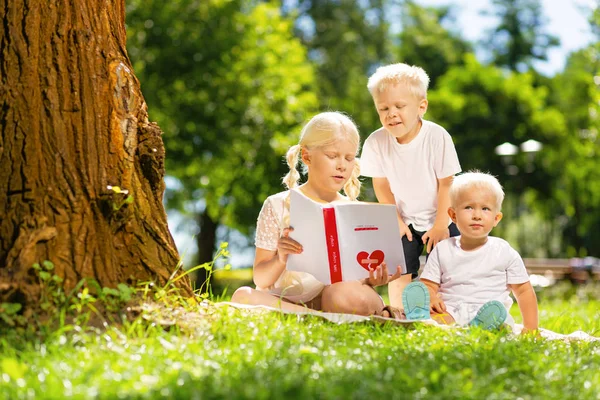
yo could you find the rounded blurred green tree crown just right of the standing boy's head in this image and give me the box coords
[427,54,565,173]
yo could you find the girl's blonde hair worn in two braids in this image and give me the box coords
[283,111,361,200]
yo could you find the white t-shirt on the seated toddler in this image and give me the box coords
[421,236,529,310]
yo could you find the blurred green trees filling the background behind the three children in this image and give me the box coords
[126,0,600,290]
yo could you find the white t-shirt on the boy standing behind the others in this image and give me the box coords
[360,120,461,231]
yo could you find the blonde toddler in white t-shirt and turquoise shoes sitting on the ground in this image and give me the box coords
[421,171,538,332]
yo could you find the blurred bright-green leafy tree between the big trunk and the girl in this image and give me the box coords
[128,0,317,288]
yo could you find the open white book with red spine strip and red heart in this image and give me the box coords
[286,190,406,284]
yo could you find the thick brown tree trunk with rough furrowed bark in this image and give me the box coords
[0,0,190,307]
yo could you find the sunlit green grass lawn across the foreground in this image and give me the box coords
[0,286,600,399]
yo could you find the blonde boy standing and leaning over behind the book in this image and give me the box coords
[360,64,461,308]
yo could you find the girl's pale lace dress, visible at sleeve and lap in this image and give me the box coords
[254,190,325,303]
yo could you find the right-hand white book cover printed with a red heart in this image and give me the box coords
[335,202,406,280]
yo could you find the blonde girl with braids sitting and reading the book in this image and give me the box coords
[231,112,400,317]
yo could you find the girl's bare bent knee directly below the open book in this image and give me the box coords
[321,281,384,315]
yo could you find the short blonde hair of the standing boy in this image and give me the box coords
[367,63,429,99]
